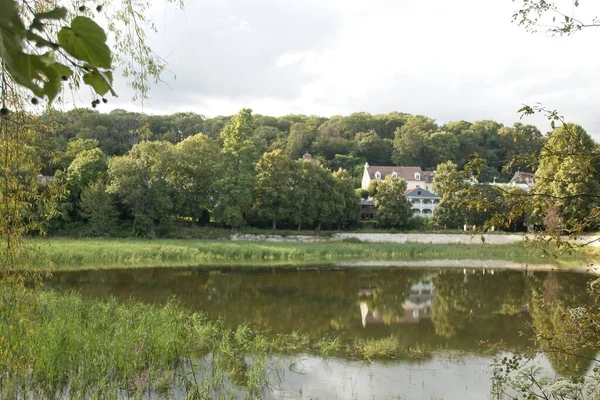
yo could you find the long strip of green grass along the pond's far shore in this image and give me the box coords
[23,239,581,270]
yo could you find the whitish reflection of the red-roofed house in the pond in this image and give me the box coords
[359,282,435,326]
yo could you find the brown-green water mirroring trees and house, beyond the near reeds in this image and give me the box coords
[48,268,589,352]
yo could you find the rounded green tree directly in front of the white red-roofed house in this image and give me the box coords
[374,175,412,228]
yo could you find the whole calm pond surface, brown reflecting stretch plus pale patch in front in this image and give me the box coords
[47,268,593,399]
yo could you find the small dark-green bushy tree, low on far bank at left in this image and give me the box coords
[79,180,119,236]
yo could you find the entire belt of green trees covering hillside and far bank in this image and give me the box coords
[21,109,598,237]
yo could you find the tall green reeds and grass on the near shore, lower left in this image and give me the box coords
[0,282,440,398]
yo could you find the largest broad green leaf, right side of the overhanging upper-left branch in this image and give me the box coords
[58,16,112,69]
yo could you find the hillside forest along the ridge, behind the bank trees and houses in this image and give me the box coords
[36,109,545,182]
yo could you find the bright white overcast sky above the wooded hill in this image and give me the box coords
[102,0,600,139]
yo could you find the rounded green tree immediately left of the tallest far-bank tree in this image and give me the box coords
[169,133,220,224]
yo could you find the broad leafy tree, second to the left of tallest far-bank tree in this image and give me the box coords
[107,141,174,237]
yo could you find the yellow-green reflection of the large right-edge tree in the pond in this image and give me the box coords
[529,273,600,376]
